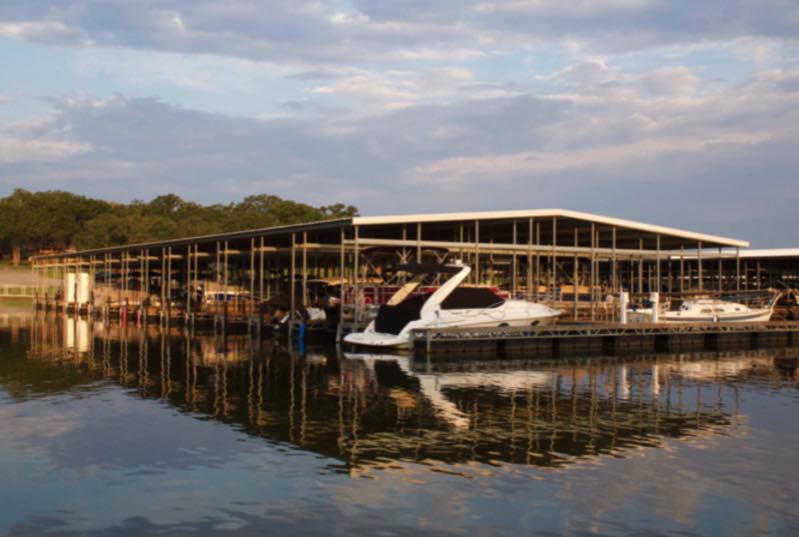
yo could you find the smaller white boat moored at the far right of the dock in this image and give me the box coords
[629,298,776,323]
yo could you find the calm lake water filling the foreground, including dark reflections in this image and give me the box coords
[0,318,799,536]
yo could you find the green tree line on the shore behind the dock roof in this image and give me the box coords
[0,189,358,264]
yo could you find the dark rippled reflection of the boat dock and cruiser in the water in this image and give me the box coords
[21,318,795,475]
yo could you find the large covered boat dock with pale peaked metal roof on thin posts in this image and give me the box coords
[33,209,751,329]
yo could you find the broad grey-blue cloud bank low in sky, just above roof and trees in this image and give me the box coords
[0,58,799,244]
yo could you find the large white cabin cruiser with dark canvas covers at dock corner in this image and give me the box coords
[344,263,561,348]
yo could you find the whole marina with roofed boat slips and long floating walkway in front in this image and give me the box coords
[32,209,799,352]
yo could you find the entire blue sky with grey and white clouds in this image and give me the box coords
[0,0,799,247]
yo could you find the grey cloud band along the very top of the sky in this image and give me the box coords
[0,0,799,65]
